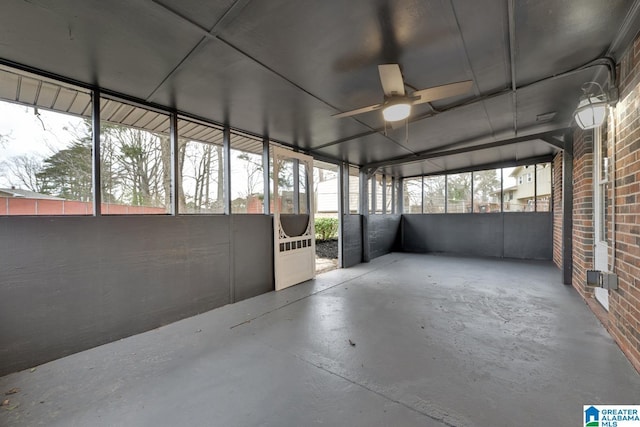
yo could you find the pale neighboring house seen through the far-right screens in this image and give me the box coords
[503,163,551,212]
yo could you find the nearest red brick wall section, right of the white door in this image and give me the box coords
[607,37,640,371]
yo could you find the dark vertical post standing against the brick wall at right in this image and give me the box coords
[562,132,573,285]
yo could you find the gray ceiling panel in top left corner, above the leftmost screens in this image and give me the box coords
[0,0,202,99]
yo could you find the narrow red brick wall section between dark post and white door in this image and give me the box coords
[571,129,593,298]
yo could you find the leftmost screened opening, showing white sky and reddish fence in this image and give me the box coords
[0,67,93,215]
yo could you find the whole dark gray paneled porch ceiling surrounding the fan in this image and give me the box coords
[0,0,640,174]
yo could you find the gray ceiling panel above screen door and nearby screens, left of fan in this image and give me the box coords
[151,40,370,149]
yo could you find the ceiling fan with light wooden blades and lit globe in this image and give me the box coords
[331,64,473,125]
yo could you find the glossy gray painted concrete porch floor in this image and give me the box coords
[0,254,640,427]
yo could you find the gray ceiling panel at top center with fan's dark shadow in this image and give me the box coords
[220,0,469,116]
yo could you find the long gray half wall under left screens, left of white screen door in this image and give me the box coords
[0,215,274,375]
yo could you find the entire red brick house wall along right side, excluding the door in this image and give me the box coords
[564,37,640,372]
